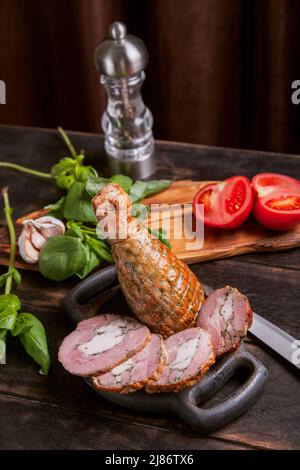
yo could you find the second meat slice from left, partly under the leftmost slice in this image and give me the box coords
[93,335,166,393]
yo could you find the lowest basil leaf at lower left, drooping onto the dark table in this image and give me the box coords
[18,312,50,375]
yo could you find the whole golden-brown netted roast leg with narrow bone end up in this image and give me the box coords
[92,183,204,337]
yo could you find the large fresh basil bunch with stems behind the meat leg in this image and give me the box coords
[0,127,171,282]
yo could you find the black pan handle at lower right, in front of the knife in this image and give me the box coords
[174,347,268,432]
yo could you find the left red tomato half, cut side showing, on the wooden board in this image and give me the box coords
[193,176,253,229]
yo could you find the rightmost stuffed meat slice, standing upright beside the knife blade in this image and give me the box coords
[197,286,253,356]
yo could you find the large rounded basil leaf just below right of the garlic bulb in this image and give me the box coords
[39,236,87,281]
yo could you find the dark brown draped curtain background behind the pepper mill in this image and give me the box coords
[0,0,300,153]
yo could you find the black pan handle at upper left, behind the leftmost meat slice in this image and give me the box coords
[62,266,118,324]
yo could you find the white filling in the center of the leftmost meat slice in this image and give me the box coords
[78,319,127,356]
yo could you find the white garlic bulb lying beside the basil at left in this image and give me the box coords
[18,215,65,264]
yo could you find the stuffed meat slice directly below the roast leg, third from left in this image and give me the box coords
[146,328,215,393]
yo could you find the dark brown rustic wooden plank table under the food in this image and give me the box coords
[0,126,300,450]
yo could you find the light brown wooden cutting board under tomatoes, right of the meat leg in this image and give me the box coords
[145,180,300,264]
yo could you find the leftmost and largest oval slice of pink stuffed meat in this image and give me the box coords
[58,314,151,376]
